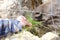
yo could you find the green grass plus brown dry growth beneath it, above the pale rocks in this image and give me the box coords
[24,14,50,37]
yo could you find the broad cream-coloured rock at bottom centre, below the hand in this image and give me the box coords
[5,31,40,40]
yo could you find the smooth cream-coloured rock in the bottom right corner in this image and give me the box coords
[41,32,59,40]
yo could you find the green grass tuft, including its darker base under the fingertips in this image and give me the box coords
[25,14,42,31]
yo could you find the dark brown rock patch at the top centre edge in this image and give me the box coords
[22,0,42,10]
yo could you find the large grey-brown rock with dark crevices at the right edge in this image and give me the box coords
[33,0,60,29]
